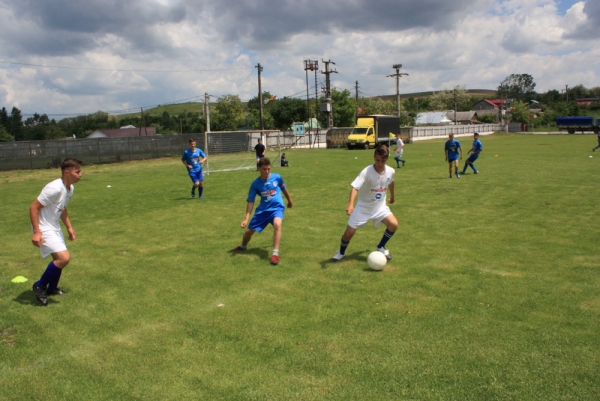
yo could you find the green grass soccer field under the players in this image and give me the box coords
[0,134,600,400]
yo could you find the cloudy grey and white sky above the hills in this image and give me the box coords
[0,0,600,116]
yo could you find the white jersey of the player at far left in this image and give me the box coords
[38,178,74,234]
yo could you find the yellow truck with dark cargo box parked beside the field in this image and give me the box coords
[347,114,400,149]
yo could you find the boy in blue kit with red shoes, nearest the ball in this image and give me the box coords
[231,157,293,265]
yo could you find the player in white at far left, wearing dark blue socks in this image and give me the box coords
[29,159,82,306]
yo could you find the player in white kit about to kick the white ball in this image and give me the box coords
[331,145,398,262]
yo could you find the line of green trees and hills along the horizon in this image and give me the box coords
[0,74,600,142]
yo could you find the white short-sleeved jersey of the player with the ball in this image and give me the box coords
[351,165,396,211]
